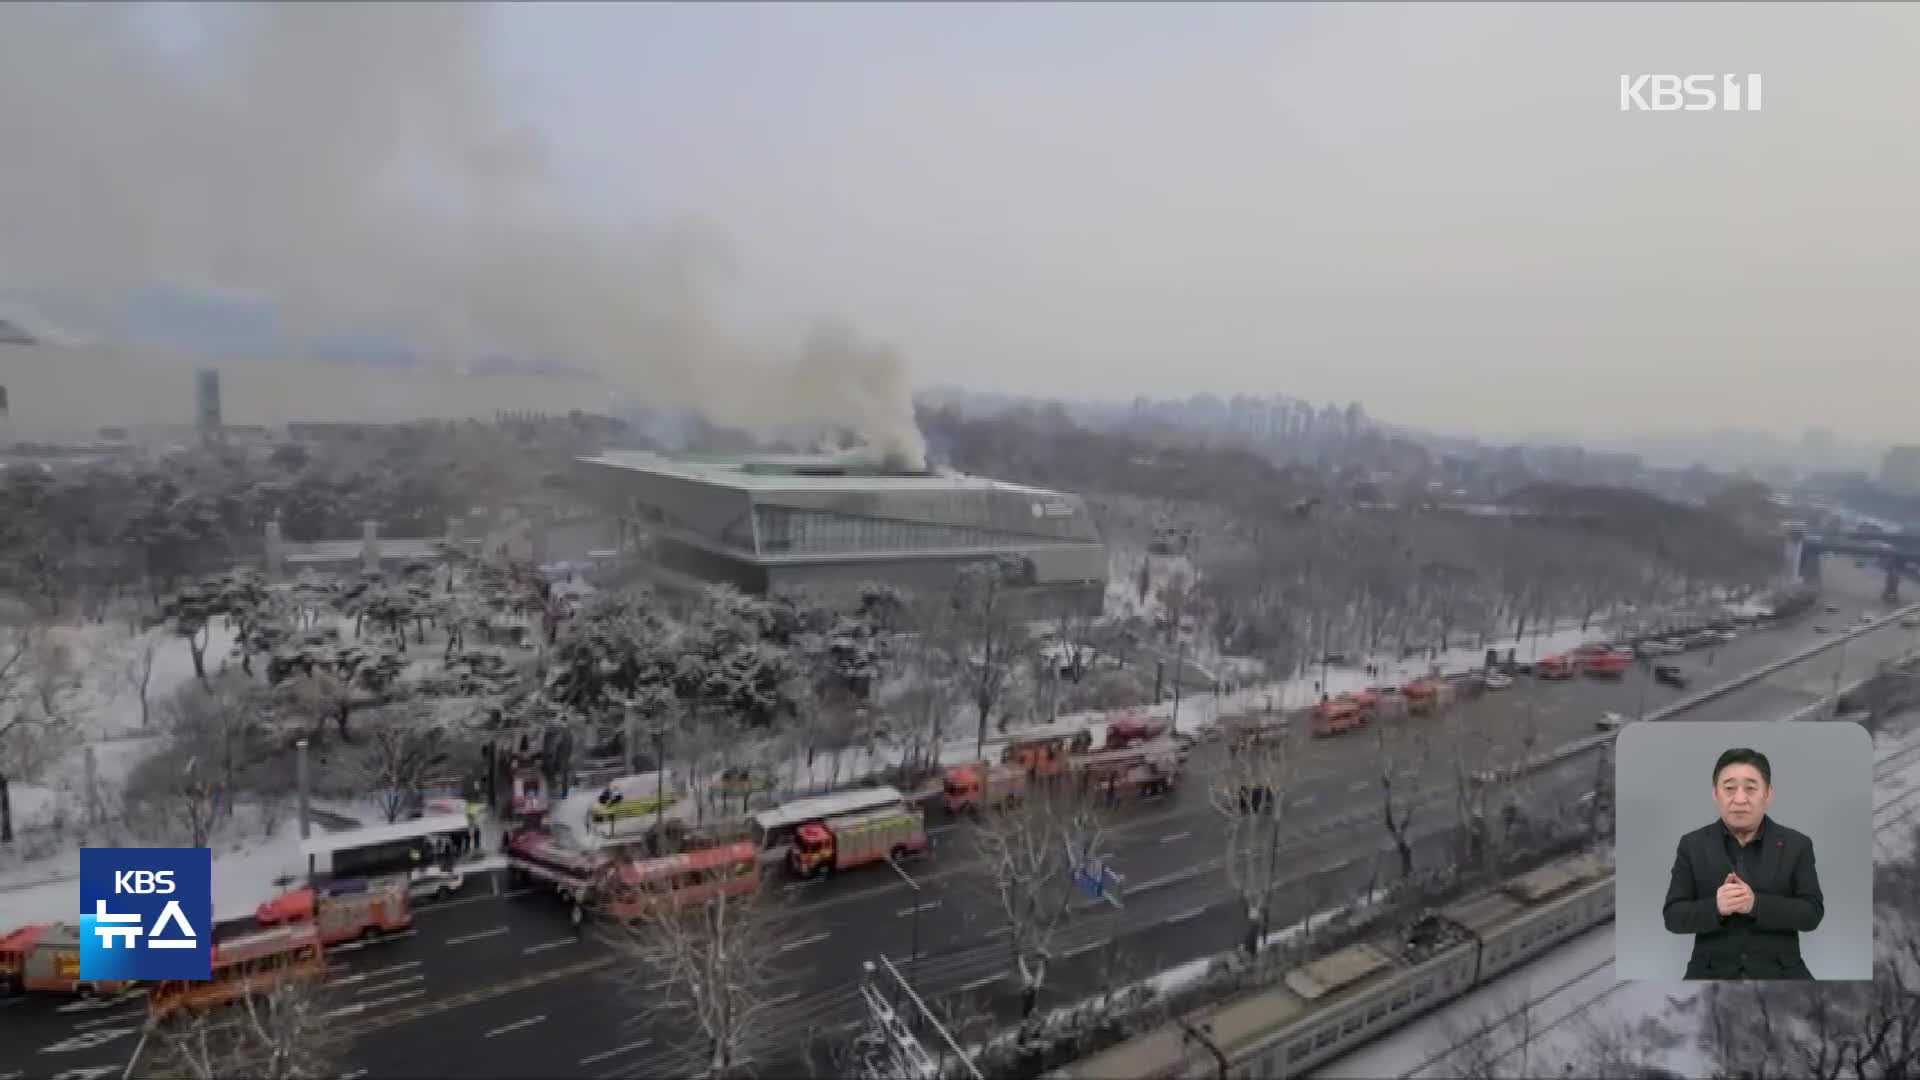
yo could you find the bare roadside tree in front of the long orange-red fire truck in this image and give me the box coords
[601,853,785,1080]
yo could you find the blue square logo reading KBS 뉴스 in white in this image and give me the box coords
[81,847,213,982]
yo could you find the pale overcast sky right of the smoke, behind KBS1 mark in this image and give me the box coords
[0,4,1920,440]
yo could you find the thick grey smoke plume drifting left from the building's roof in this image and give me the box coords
[0,4,924,465]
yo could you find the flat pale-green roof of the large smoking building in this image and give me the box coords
[580,450,1066,498]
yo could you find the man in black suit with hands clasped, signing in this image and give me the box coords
[1665,748,1826,978]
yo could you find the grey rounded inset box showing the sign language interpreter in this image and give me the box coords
[1613,721,1874,980]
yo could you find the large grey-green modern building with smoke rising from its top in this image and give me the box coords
[578,452,1108,613]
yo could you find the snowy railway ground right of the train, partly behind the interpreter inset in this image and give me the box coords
[1315,732,1920,1080]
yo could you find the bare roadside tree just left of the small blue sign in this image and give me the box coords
[970,776,1108,1017]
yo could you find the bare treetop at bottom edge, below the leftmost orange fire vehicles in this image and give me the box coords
[142,978,346,1080]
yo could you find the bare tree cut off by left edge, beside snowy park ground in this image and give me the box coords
[0,623,81,844]
